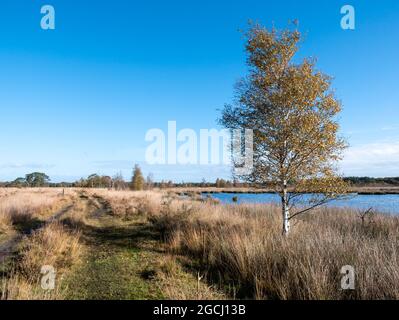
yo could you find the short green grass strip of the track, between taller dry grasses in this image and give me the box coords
[66,195,164,300]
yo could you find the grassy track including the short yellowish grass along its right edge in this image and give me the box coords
[64,194,226,300]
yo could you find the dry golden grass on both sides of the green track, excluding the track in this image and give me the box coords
[0,189,399,299]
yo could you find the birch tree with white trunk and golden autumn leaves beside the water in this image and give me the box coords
[220,25,347,235]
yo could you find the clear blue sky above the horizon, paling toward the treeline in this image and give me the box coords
[0,0,399,181]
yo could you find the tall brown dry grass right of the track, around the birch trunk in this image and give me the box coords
[151,200,399,299]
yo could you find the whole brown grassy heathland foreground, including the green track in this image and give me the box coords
[0,189,399,300]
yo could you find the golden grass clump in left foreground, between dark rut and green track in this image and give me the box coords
[1,222,82,300]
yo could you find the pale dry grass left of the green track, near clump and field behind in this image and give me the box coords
[0,188,81,300]
